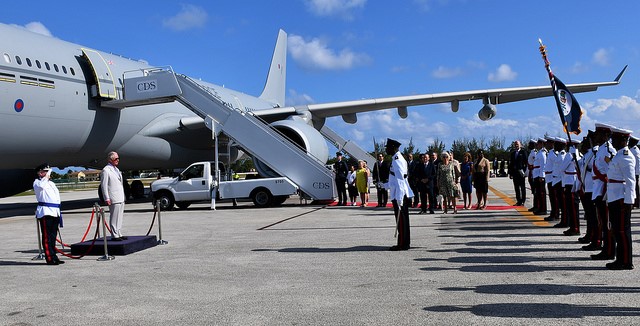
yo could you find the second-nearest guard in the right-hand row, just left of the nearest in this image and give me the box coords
[590,123,616,260]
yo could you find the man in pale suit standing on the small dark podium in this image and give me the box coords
[100,152,127,241]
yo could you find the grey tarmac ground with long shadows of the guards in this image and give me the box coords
[0,178,640,325]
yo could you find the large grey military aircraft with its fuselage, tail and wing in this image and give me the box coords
[0,24,624,197]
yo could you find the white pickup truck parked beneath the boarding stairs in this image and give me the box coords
[151,162,298,210]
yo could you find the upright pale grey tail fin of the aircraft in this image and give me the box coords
[260,30,287,107]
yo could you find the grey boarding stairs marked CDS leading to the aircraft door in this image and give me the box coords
[103,69,335,201]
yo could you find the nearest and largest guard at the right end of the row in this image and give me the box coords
[607,128,636,270]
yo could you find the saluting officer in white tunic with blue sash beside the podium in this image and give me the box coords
[33,163,64,265]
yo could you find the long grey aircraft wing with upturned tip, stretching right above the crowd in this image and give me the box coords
[254,66,627,122]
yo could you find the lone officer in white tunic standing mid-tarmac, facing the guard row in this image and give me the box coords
[385,138,413,251]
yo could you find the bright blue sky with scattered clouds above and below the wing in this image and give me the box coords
[0,0,640,155]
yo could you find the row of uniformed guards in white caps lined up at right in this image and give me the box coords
[524,123,640,270]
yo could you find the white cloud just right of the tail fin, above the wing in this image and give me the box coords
[288,34,371,70]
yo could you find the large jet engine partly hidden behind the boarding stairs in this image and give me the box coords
[253,118,329,178]
